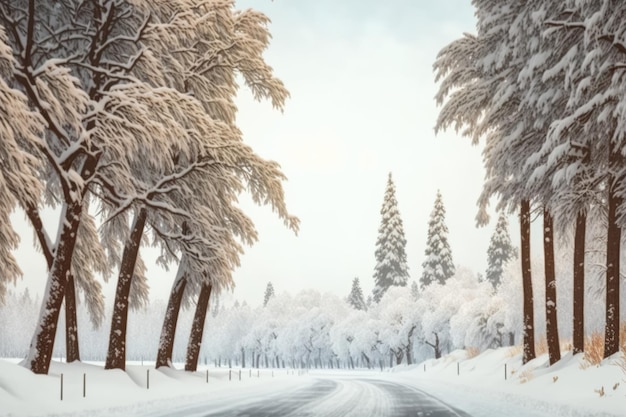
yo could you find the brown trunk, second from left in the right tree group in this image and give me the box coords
[543,208,561,365]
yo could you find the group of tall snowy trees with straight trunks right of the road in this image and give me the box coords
[434,0,626,364]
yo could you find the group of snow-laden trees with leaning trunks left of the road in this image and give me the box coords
[0,0,298,373]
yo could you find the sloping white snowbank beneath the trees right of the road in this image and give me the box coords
[386,348,626,417]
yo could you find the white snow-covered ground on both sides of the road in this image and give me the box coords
[0,348,626,417]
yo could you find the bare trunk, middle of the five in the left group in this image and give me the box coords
[104,208,148,370]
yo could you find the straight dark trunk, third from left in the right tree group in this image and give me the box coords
[573,211,587,355]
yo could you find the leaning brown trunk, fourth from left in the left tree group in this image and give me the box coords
[155,264,186,369]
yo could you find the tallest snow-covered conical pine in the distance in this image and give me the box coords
[373,173,409,302]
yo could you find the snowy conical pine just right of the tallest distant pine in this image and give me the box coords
[421,191,455,288]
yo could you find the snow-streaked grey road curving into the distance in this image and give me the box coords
[201,376,470,417]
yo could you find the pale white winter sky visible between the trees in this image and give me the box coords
[9,0,508,305]
